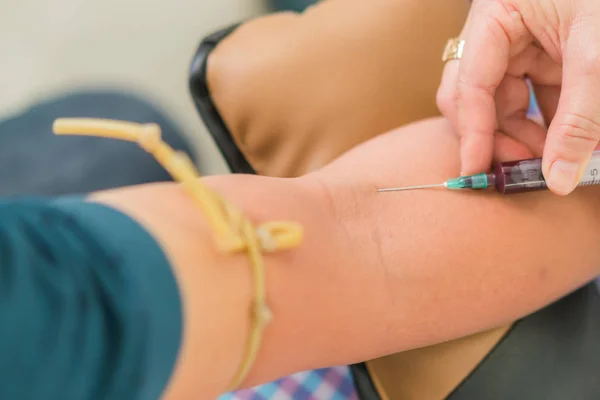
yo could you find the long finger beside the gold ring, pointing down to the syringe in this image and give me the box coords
[457,0,527,175]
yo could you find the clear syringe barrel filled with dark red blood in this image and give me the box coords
[493,150,600,194]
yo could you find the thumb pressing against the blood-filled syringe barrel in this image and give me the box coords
[542,25,600,195]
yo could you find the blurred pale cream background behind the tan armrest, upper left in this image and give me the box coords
[0,0,314,174]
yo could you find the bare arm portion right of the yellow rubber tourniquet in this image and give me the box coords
[199,120,600,390]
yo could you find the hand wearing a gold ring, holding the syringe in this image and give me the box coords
[438,0,600,195]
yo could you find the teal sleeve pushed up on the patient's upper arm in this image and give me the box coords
[0,199,182,400]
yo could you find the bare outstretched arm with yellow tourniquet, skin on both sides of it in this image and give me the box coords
[91,119,600,399]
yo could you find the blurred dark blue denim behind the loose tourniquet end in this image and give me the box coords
[0,91,192,196]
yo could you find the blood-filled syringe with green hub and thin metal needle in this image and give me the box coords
[377,150,600,194]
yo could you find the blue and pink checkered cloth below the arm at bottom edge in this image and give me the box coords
[218,367,358,400]
